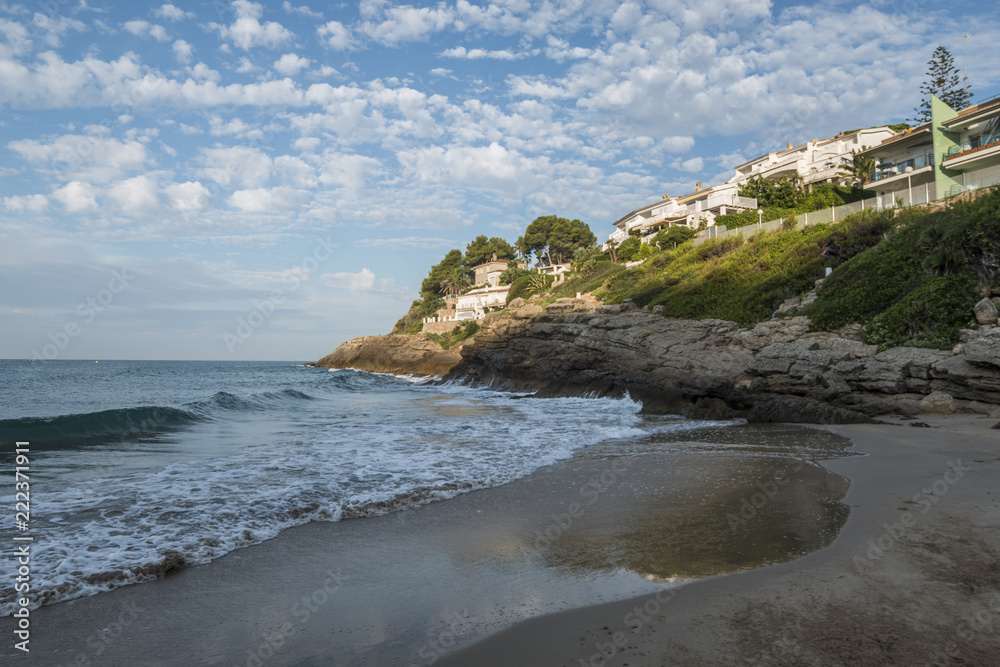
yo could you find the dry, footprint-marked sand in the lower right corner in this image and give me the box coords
[440,415,1000,666]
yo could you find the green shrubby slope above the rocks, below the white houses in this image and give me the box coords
[550,191,1000,349]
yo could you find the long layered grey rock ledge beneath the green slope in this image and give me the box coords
[447,299,1000,423]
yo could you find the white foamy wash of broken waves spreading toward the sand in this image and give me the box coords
[0,384,732,615]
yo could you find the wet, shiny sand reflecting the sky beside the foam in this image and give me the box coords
[0,426,862,666]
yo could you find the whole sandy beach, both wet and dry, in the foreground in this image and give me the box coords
[0,416,1000,666]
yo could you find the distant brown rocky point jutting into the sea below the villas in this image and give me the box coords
[316,334,462,376]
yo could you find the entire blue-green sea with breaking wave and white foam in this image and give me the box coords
[0,360,860,615]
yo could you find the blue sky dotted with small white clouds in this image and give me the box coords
[0,0,1000,361]
